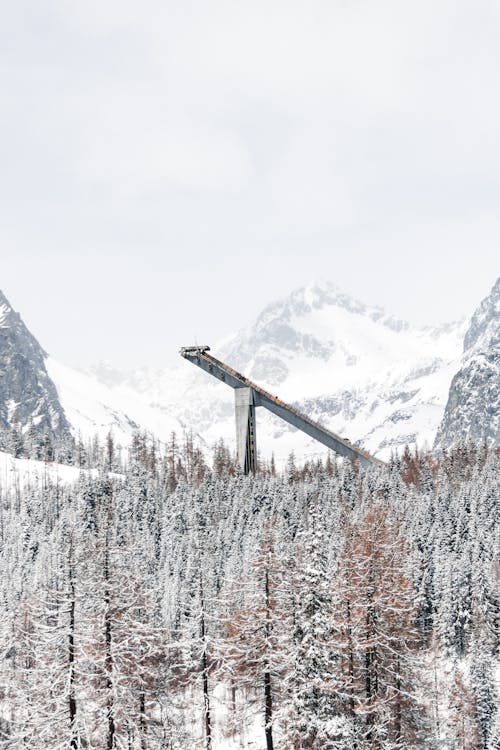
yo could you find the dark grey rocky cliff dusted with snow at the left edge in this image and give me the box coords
[0,292,70,450]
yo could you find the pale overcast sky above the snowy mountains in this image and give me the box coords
[0,0,500,366]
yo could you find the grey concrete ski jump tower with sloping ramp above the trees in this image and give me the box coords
[180,346,384,474]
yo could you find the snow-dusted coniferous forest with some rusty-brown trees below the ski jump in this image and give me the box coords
[0,434,500,750]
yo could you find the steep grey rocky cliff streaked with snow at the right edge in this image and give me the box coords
[435,278,500,448]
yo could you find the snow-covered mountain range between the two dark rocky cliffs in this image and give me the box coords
[53,283,465,462]
